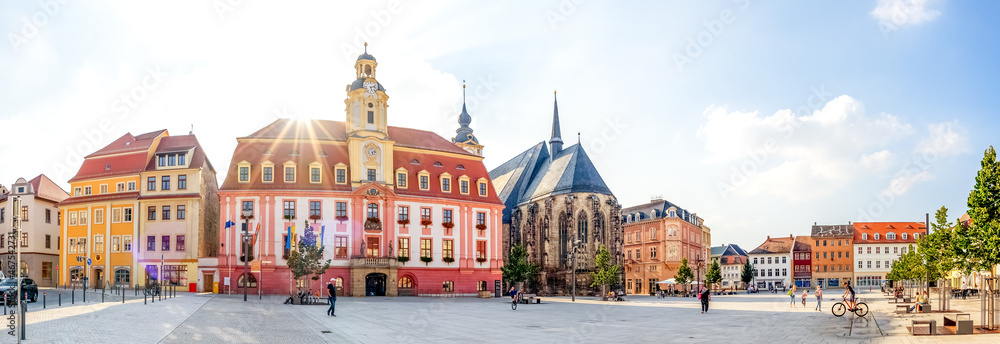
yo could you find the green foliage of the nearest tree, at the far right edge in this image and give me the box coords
[953,146,1000,273]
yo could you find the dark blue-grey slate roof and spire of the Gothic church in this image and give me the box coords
[490,93,613,223]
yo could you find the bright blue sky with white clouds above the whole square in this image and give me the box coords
[0,0,1000,250]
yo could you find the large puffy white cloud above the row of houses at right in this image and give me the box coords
[698,96,913,200]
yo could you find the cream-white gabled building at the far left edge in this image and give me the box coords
[0,174,69,287]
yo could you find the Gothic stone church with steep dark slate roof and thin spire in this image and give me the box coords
[490,93,623,295]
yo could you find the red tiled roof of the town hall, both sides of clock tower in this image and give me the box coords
[220,119,501,204]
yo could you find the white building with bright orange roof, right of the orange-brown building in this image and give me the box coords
[854,222,927,288]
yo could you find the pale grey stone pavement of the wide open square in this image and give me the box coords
[0,291,1000,344]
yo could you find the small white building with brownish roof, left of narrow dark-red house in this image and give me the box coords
[747,235,795,290]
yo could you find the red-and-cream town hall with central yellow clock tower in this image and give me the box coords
[212,44,503,296]
